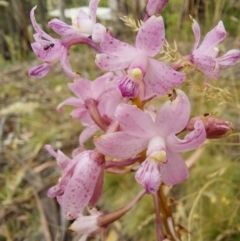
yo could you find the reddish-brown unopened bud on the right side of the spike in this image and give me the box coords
[186,113,233,139]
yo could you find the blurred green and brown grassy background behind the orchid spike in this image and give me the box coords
[0,0,240,241]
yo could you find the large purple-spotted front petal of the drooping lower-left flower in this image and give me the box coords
[62,151,101,219]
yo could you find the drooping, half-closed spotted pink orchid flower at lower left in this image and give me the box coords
[45,145,105,219]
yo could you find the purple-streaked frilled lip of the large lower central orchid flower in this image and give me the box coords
[135,159,161,194]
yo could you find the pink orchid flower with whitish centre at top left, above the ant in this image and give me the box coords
[48,0,106,42]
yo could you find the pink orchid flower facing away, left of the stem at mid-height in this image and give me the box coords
[57,72,121,146]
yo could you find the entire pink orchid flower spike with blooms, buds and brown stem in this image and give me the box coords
[29,0,240,241]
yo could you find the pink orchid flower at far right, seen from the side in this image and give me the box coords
[187,19,240,79]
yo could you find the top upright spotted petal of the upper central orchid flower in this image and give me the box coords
[135,16,165,57]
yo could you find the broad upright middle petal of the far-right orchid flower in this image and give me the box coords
[196,21,226,54]
